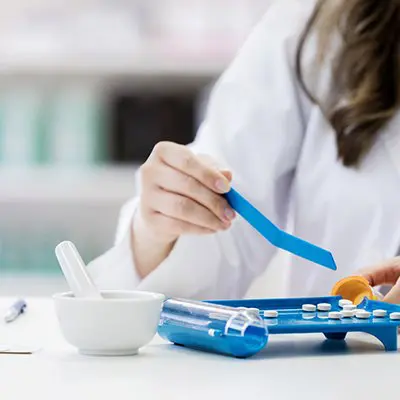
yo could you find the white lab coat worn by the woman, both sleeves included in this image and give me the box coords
[89,0,400,298]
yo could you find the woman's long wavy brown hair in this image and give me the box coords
[296,0,400,166]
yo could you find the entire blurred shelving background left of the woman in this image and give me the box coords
[0,0,278,295]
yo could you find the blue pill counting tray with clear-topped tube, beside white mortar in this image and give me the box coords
[158,296,400,357]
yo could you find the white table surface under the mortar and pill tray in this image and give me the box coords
[0,298,400,400]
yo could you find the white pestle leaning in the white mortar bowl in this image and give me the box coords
[55,242,103,299]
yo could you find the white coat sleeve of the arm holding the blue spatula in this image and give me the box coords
[86,0,314,299]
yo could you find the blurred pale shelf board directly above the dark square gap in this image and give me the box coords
[0,46,233,83]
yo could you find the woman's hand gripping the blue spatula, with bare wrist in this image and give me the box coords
[132,142,235,277]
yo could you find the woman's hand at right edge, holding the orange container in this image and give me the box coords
[360,257,400,304]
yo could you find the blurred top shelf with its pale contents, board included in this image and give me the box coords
[0,0,271,80]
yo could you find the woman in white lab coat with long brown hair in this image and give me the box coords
[90,0,400,301]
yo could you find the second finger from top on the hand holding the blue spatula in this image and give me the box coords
[154,165,235,222]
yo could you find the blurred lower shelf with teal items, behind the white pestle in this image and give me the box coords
[0,166,132,282]
